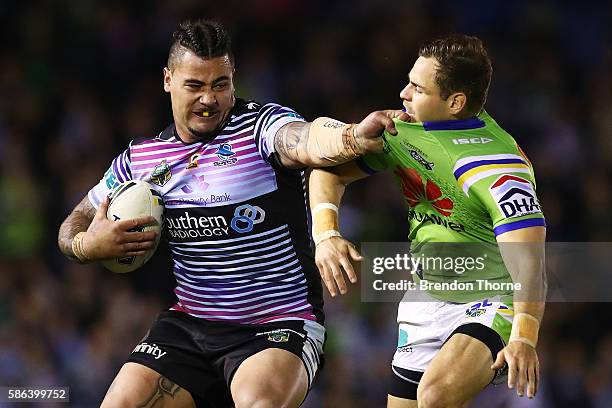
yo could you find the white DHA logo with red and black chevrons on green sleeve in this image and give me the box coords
[489,174,542,218]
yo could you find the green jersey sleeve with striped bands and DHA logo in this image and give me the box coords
[453,149,546,236]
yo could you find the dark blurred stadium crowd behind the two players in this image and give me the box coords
[0,0,612,408]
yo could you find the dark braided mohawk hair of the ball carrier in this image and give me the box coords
[168,19,234,69]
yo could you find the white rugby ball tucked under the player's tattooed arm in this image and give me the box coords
[101,180,164,273]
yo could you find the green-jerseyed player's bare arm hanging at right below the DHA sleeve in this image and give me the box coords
[491,227,546,398]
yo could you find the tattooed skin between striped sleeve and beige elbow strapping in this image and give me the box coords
[274,122,310,168]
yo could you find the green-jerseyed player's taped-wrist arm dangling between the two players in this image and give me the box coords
[310,162,368,296]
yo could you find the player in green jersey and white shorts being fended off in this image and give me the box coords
[310,35,546,408]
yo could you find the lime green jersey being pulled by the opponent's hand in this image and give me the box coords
[357,112,545,302]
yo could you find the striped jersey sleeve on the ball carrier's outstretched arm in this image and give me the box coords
[255,103,305,161]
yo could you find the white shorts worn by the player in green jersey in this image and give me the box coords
[391,297,514,396]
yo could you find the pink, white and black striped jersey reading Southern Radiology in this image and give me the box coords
[89,99,323,324]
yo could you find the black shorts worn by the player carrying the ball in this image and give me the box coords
[127,310,325,407]
